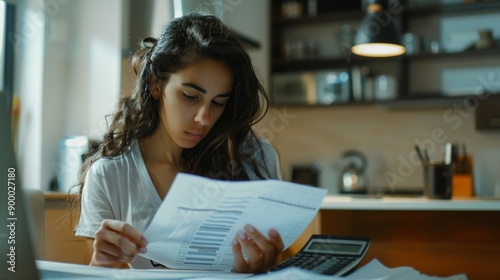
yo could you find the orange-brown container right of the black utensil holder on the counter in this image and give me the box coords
[452,156,474,198]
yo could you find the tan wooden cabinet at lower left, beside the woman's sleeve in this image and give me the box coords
[45,193,85,264]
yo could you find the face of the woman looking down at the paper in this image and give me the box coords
[160,59,233,148]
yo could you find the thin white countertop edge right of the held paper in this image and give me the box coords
[321,195,500,211]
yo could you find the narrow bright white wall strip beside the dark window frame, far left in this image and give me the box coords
[14,0,44,192]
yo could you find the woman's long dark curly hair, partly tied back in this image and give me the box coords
[75,13,269,214]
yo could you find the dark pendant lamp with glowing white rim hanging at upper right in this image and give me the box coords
[351,0,406,57]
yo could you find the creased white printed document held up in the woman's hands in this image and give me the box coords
[143,173,327,270]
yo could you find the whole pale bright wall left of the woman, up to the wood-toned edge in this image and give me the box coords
[16,0,122,189]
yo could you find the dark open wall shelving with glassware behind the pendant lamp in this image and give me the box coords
[270,0,500,106]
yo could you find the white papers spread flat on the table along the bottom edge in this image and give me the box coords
[36,259,467,280]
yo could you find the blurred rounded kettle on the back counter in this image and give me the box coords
[339,150,367,194]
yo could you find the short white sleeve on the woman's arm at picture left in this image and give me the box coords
[75,161,116,238]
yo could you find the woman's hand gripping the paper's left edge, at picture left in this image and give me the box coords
[90,220,147,267]
